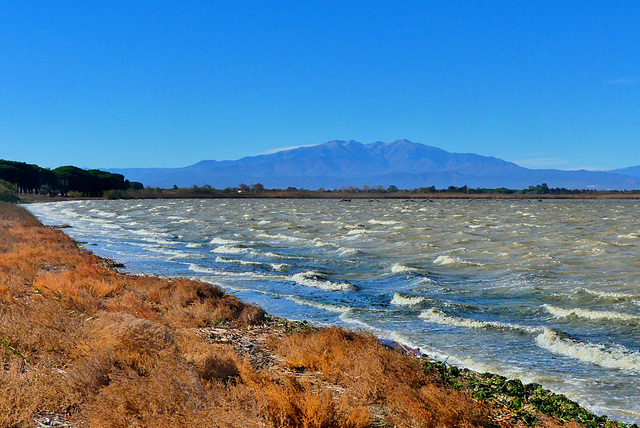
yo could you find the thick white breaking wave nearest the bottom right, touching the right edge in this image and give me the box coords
[536,327,640,372]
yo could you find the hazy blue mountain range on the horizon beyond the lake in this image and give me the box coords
[108,140,640,190]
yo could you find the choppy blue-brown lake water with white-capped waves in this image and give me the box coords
[26,199,640,423]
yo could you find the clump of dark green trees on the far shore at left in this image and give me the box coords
[0,159,144,197]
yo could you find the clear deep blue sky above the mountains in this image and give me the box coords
[0,0,640,169]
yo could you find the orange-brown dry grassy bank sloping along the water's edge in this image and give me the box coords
[0,204,624,427]
